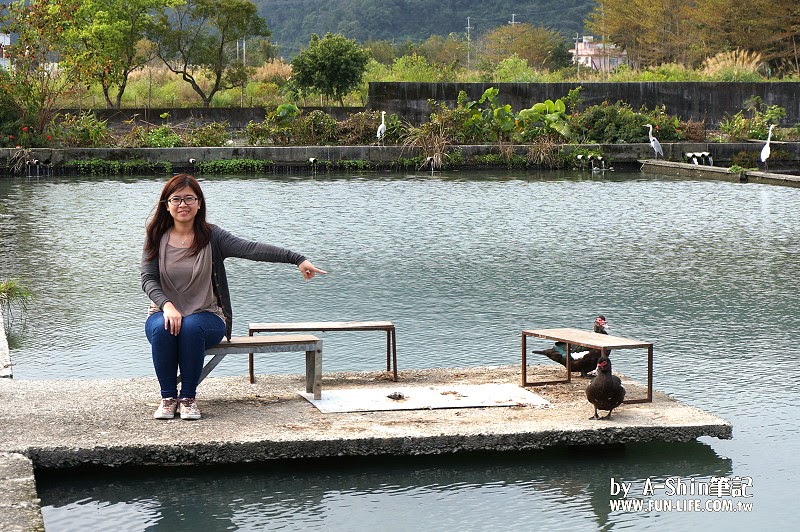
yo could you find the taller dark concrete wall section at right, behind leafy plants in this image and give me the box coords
[367,82,800,128]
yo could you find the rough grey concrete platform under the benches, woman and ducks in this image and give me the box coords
[0,361,732,468]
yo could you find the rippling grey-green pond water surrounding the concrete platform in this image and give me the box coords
[0,172,800,531]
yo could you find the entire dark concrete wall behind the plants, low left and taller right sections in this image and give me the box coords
[64,81,800,129]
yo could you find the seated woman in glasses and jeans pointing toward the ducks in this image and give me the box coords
[142,174,327,419]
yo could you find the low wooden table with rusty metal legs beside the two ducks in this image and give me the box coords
[522,327,653,403]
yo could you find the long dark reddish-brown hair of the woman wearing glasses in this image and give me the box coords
[144,174,211,260]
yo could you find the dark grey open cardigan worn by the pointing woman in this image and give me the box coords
[142,225,306,339]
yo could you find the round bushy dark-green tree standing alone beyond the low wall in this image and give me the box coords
[292,33,370,107]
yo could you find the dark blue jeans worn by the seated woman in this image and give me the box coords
[144,312,225,399]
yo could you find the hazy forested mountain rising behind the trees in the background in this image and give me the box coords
[254,0,595,59]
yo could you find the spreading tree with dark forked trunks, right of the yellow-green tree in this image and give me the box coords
[152,0,270,107]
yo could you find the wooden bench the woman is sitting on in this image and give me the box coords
[178,334,322,399]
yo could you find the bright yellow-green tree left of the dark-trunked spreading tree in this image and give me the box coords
[76,0,174,108]
